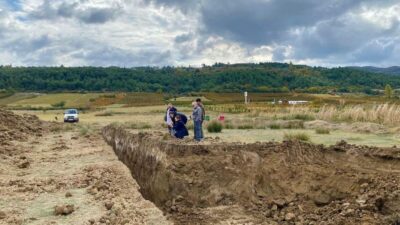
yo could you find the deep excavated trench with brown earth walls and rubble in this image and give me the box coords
[102,126,400,225]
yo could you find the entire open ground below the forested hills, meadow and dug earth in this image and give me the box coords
[0,93,400,225]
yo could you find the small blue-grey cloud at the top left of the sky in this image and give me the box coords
[30,0,122,24]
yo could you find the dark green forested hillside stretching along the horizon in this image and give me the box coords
[0,63,400,94]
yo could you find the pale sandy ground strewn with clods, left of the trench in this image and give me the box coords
[0,111,170,225]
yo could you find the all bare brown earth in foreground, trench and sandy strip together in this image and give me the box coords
[0,110,400,225]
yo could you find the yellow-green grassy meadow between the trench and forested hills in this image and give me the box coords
[0,93,400,147]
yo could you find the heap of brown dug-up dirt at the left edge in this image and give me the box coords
[0,109,43,145]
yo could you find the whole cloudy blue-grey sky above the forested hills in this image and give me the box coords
[0,0,400,67]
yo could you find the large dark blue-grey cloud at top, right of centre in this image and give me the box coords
[202,0,396,45]
